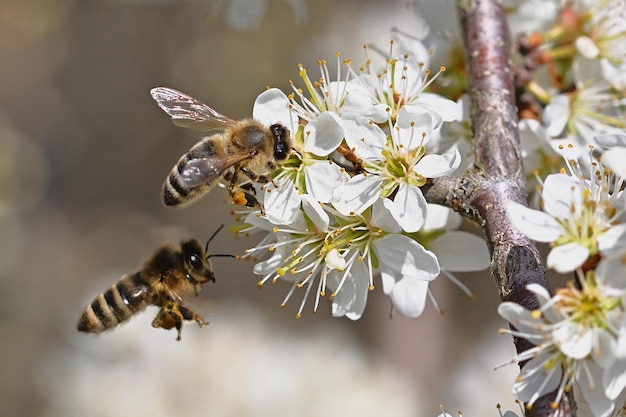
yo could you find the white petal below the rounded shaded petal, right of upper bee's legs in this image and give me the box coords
[304,161,350,203]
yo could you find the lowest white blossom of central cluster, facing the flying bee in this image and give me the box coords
[240,196,439,320]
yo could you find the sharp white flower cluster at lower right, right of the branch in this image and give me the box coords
[499,143,626,416]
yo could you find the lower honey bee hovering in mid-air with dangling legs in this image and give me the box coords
[77,226,232,340]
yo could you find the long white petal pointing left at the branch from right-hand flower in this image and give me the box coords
[506,201,563,242]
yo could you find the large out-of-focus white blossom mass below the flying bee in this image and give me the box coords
[39,300,421,417]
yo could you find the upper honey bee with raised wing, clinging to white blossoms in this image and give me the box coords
[150,87,292,209]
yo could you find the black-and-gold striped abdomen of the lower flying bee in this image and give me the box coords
[77,273,150,333]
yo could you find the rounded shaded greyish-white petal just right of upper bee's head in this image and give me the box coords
[304,111,344,156]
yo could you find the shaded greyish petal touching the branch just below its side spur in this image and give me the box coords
[428,231,491,272]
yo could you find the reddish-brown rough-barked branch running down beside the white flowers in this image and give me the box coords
[424,0,575,416]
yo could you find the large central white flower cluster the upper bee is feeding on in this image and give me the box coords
[237,46,489,320]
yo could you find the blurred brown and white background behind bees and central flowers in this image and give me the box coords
[0,0,516,416]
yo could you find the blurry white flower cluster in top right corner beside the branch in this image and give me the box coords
[520,0,626,171]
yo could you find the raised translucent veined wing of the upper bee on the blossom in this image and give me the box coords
[150,87,236,131]
